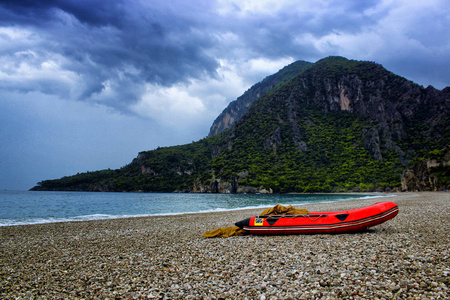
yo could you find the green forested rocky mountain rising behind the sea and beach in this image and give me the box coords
[33,57,450,193]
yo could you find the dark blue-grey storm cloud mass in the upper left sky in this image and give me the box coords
[0,0,218,106]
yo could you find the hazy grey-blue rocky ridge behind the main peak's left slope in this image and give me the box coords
[209,61,312,136]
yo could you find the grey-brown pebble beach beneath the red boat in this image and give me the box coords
[0,192,450,299]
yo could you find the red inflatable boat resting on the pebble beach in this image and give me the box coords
[235,201,398,235]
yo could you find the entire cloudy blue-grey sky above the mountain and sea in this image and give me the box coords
[0,0,450,190]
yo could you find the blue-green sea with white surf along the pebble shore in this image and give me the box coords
[0,191,385,226]
